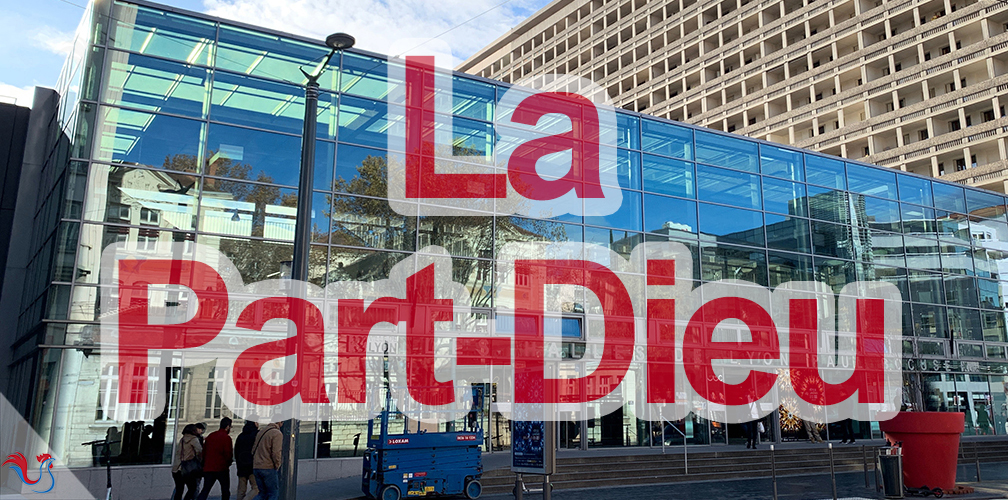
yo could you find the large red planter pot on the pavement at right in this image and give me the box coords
[879,411,966,491]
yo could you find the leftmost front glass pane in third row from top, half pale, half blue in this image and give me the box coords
[94,106,203,171]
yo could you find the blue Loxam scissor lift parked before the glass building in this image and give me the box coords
[361,387,483,500]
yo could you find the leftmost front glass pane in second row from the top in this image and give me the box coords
[102,50,210,118]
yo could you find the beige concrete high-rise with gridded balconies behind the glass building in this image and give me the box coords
[459,0,1008,193]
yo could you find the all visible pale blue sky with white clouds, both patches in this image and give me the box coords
[0,0,548,106]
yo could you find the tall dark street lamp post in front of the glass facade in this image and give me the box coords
[280,33,356,500]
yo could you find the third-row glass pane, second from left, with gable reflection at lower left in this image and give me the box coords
[206,123,301,185]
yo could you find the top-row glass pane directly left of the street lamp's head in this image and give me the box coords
[216,25,340,90]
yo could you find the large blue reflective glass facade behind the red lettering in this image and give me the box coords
[15,1,1008,467]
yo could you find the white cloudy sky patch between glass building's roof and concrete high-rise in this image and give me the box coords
[204,0,547,66]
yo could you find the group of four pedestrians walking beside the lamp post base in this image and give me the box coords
[171,417,283,500]
